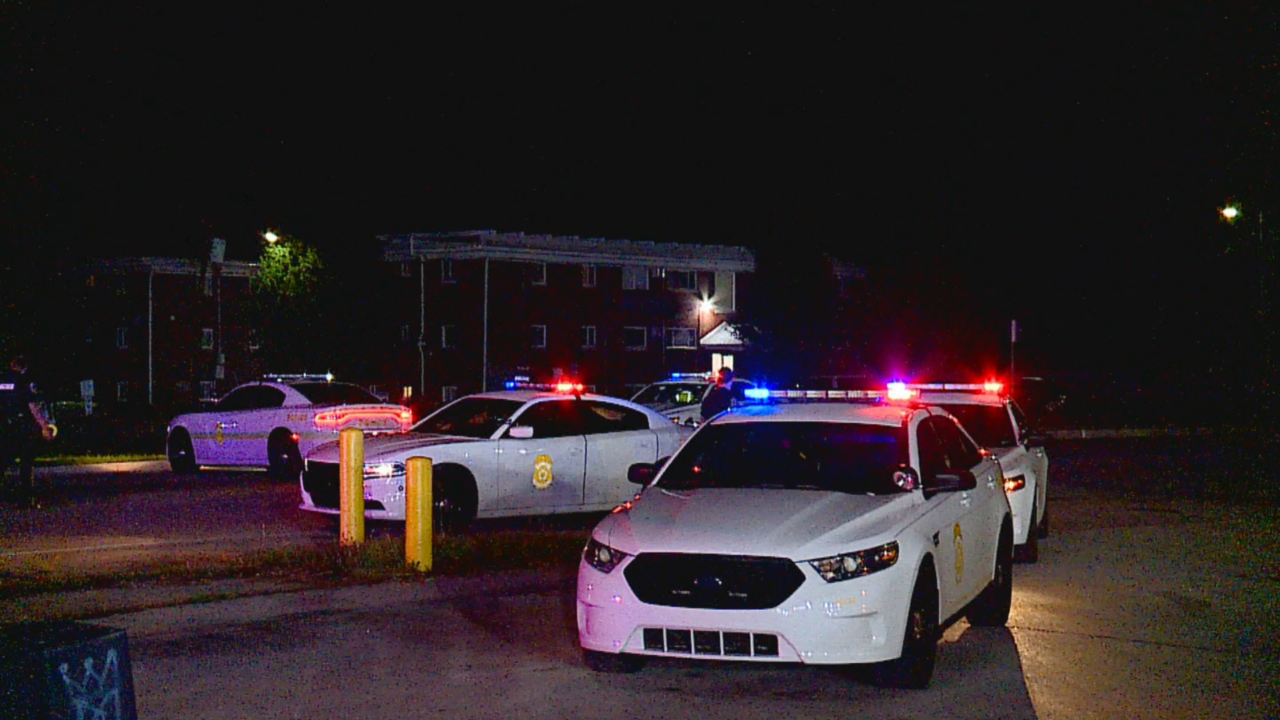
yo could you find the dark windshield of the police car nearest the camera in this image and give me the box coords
[658,421,908,495]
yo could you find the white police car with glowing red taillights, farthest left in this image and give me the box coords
[166,375,413,478]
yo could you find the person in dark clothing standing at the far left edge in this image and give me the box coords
[0,355,58,505]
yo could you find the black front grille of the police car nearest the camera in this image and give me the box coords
[623,552,804,610]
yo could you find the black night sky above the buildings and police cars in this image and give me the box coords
[0,3,1280,415]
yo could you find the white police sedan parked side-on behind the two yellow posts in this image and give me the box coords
[301,383,692,528]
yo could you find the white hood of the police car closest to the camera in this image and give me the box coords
[595,486,918,560]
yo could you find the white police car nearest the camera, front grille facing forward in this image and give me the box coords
[577,391,1012,687]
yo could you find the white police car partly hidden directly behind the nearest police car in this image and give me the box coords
[901,380,1048,562]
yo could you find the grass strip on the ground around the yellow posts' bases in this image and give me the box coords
[0,529,589,602]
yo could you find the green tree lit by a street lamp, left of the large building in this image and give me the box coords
[250,234,328,373]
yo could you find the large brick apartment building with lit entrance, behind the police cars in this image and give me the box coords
[379,231,755,406]
